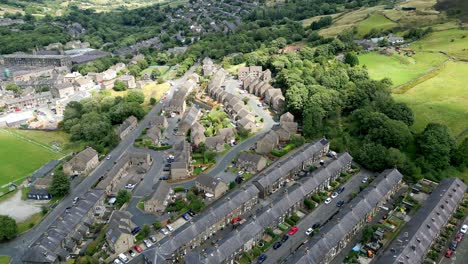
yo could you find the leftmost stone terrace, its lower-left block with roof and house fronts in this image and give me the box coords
[143,184,258,263]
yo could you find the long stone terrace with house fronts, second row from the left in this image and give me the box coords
[203,153,351,264]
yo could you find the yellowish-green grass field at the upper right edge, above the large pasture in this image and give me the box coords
[410,29,468,59]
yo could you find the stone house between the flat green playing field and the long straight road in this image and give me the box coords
[63,147,99,176]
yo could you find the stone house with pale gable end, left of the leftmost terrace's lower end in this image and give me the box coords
[106,211,136,253]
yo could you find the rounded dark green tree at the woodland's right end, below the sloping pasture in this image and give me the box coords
[417,123,455,170]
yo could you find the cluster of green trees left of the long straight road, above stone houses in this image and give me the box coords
[59,91,145,152]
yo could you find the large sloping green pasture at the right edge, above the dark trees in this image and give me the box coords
[393,62,468,137]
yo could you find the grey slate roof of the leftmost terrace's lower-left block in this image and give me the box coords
[147,184,258,263]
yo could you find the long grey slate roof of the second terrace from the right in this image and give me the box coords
[293,169,403,264]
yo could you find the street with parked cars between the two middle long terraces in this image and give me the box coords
[265,170,373,263]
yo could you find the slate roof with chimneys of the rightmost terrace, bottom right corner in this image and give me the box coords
[377,178,467,264]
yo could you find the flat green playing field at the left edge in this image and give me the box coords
[0,130,63,187]
